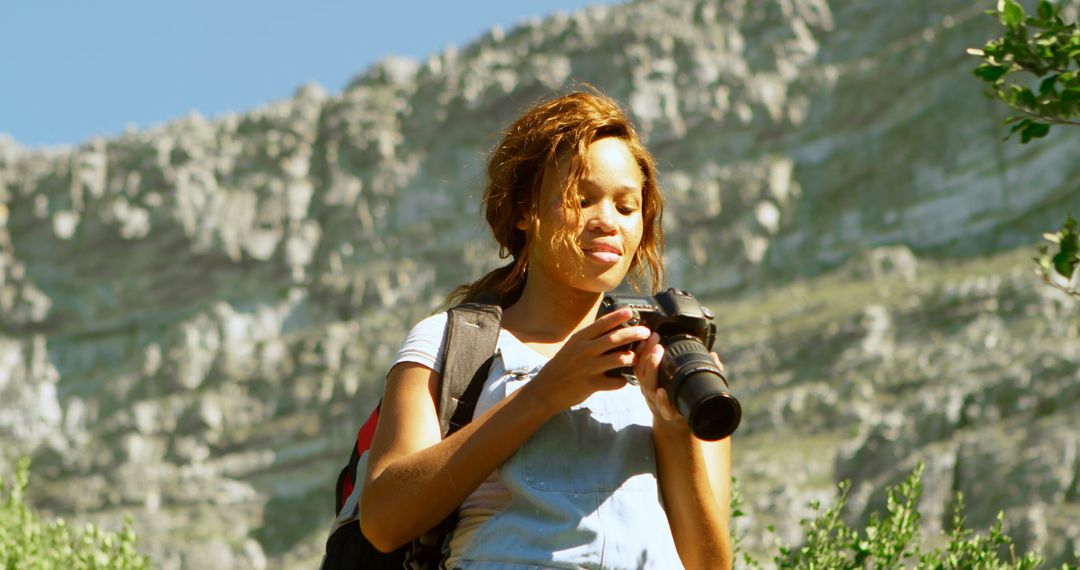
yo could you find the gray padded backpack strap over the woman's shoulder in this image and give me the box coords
[438,303,502,437]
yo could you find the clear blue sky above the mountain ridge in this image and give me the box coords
[0,0,619,147]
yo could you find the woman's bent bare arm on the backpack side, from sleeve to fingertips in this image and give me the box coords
[360,311,649,552]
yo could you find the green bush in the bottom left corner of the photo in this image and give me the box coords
[0,459,150,570]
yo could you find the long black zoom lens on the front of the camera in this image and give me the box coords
[660,335,742,442]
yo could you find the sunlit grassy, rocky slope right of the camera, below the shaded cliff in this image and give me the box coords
[730,248,1080,560]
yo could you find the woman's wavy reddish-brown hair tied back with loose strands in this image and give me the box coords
[447,89,664,308]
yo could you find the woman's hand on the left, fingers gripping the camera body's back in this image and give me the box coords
[529,309,651,413]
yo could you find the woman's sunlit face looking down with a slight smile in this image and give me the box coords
[517,137,645,293]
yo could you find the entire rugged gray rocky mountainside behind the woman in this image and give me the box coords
[0,0,1080,568]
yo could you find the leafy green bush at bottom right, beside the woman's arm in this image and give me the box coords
[731,463,1077,570]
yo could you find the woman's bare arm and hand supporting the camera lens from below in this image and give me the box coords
[636,335,732,570]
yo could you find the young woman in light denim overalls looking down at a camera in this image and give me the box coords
[361,92,731,570]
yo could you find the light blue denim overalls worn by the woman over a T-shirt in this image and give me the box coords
[451,339,683,570]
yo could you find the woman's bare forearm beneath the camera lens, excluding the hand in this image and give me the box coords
[653,421,732,570]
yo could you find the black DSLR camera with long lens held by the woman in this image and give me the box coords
[596,289,742,442]
